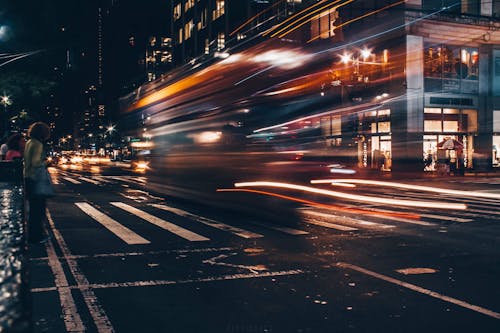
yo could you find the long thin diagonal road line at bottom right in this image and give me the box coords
[337,262,500,319]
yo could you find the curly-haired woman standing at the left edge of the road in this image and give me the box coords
[24,122,50,243]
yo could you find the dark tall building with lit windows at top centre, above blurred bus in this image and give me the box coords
[171,0,302,66]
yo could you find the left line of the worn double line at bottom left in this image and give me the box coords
[45,235,86,332]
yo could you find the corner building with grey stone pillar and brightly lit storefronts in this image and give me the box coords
[320,0,500,173]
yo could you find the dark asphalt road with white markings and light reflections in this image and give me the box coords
[29,169,500,333]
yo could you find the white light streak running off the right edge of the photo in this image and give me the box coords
[311,179,500,199]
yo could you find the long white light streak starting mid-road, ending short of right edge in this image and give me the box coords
[234,181,467,210]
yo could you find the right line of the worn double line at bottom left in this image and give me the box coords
[46,209,115,333]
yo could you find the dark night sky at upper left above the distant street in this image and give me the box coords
[0,0,170,132]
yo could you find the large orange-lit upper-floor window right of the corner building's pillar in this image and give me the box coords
[424,44,479,94]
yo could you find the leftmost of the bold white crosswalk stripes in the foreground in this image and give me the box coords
[75,202,151,245]
